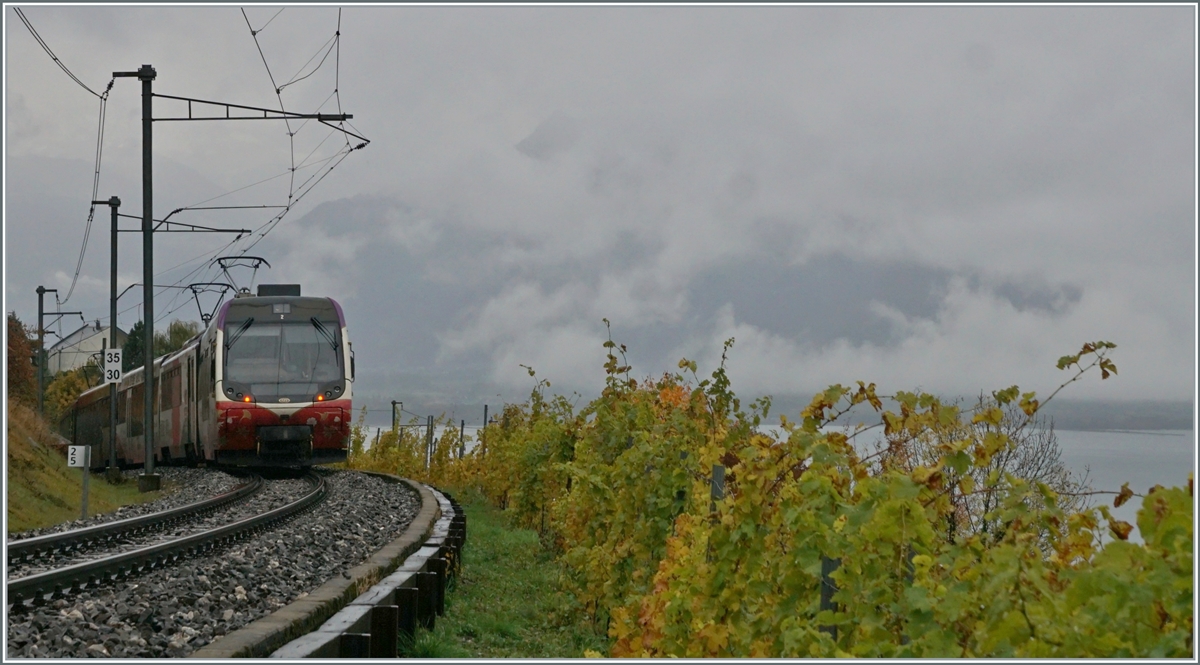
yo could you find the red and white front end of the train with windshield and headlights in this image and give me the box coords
[215,295,354,467]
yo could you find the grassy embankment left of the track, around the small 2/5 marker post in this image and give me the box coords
[6,400,161,533]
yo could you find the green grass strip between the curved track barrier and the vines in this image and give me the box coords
[420,492,608,658]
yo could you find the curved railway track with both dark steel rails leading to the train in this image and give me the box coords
[5,473,326,604]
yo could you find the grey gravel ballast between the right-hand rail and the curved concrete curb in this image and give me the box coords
[7,472,420,658]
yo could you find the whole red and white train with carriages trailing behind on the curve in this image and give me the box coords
[59,284,354,469]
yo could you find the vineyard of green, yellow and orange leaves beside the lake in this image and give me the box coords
[348,340,1194,658]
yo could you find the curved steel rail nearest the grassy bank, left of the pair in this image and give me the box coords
[7,474,263,565]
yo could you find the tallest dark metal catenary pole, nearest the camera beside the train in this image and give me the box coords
[138,65,158,492]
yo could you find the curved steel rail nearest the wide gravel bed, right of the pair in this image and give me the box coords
[5,473,326,602]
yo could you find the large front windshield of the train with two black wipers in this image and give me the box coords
[224,317,342,401]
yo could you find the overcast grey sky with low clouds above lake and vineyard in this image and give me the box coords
[5,5,1196,400]
